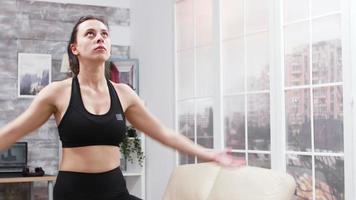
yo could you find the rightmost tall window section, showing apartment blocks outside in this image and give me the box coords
[284,0,345,199]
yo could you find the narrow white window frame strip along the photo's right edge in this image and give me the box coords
[348,0,356,200]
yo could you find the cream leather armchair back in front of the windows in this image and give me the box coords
[163,163,296,200]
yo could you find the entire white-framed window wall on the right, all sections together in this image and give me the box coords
[175,0,350,200]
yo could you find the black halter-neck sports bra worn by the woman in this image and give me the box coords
[58,76,127,147]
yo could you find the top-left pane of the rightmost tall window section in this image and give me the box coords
[284,0,309,23]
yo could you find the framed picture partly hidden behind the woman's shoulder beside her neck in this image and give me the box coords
[109,58,139,94]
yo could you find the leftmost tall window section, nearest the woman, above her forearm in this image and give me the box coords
[176,0,214,164]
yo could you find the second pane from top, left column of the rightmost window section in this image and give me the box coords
[284,22,310,86]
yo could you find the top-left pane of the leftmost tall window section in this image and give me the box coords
[176,0,194,50]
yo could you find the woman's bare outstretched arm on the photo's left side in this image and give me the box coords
[0,83,56,151]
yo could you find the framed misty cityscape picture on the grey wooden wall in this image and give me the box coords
[17,53,52,98]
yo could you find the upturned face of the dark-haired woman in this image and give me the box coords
[71,20,111,62]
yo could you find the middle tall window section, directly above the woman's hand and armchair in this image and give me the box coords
[220,0,271,168]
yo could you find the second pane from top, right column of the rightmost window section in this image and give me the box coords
[312,15,342,84]
